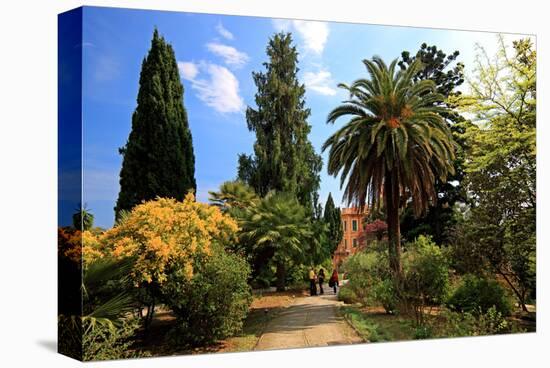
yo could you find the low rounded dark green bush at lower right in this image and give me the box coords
[447,274,512,316]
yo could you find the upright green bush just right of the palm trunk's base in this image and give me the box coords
[399,235,449,325]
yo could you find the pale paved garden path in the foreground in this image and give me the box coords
[254,291,362,350]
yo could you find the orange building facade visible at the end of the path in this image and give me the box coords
[332,208,367,268]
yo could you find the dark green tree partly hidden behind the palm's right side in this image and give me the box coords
[398,43,466,244]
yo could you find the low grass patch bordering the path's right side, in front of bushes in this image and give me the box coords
[341,306,415,342]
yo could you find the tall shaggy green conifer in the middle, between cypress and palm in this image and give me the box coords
[238,33,322,211]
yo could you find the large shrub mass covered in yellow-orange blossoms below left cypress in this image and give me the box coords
[101,194,239,284]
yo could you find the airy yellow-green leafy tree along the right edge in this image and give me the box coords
[453,38,536,311]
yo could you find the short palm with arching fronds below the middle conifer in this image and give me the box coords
[241,193,312,291]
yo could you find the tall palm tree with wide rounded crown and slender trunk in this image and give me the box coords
[323,56,455,276]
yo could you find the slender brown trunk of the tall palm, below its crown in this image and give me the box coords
[384,172,402,278]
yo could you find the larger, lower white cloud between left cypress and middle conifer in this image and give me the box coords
[178,62,244,113]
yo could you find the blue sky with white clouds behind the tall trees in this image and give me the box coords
[82,7,532,227]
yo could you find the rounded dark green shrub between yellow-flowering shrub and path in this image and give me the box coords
[163,249,252,346]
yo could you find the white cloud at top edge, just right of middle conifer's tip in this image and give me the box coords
[272,19,329,55]
